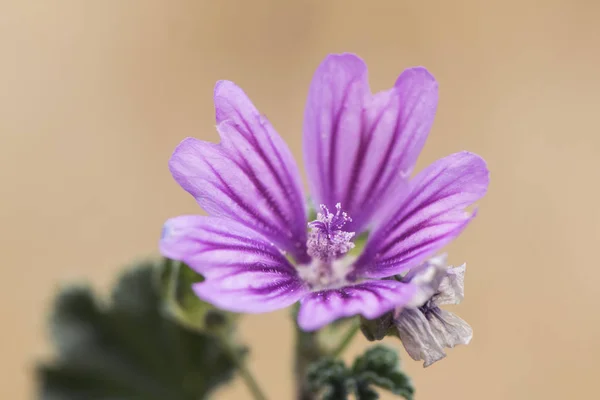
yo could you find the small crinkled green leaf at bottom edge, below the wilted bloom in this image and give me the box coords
[307,346,414,400]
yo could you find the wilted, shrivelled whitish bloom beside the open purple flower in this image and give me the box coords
[392,255,473,367]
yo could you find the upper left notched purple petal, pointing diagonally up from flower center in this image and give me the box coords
[169,81,308,262]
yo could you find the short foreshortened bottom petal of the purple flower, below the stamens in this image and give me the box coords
[298,280,416,331]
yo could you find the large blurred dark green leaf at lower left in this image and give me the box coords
[37,262,239,400]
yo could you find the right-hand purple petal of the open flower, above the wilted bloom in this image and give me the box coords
[351,152,489,278]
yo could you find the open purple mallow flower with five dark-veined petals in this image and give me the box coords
[160,54,488,330]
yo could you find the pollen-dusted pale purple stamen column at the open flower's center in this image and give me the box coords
[299,203,354,289]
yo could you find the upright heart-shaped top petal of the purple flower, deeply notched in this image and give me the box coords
[304,54,438,232]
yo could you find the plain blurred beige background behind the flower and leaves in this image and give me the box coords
[0,0,600,400]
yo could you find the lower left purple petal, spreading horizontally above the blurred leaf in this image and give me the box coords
[160,216,308,313]
